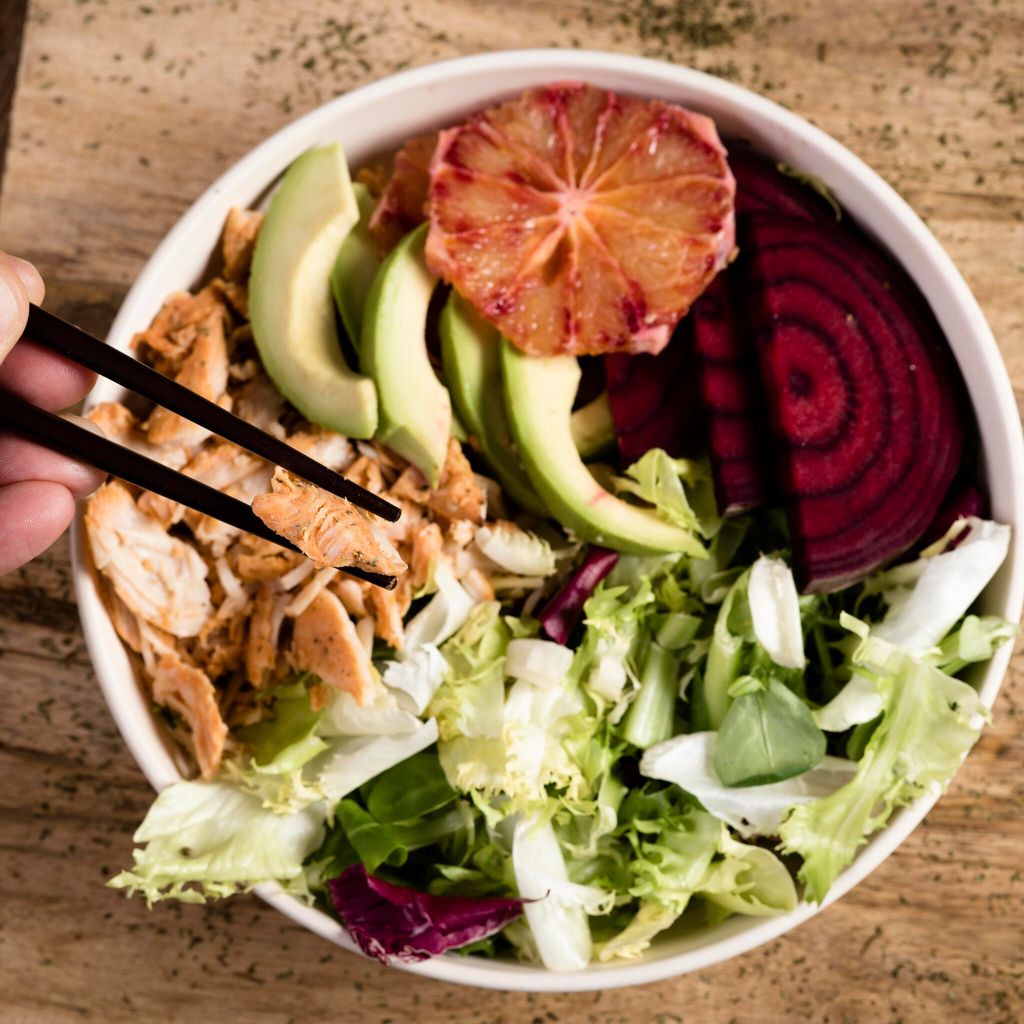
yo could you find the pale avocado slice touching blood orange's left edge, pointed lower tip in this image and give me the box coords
[359,224,452,487]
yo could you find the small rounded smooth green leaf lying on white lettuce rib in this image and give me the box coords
[715,679,825,785]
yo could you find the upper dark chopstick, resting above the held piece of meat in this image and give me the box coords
[26,305,401,532]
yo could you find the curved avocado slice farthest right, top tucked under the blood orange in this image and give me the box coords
[502,340,700,555]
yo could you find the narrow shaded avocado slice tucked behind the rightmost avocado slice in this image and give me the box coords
[438,292,548,515]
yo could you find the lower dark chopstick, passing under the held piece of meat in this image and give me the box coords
[0,390,397,590]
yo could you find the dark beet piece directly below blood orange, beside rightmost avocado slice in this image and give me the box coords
[604,321,705,463]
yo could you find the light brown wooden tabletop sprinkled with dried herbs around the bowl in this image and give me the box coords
[0,0,1024,1024]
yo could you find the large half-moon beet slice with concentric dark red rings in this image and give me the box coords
[744,214,963,593]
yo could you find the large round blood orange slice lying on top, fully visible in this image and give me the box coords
[427,82,735,355]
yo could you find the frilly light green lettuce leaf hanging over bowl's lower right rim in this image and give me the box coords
[779,635,989,902]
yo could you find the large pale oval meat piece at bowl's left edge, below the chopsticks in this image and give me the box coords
[85,480,212,637]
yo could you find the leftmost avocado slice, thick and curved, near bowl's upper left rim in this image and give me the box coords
[249,144,377,437]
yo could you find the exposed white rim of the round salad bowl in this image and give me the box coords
[72,48,1024,991]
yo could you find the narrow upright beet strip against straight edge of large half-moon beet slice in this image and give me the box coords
[689,267,777,515]
